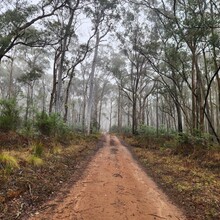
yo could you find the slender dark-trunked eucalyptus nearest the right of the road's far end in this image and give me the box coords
[114,9,154,134]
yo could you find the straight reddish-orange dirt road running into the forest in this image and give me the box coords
[31,135,185,220]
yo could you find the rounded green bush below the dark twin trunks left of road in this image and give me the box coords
[35,112,70,136]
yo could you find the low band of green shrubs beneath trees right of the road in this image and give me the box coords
[131,125,216,156]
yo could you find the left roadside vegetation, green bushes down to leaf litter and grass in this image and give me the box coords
[0,100,100,219]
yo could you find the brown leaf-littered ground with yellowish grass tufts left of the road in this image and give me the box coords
[0,132,102,220]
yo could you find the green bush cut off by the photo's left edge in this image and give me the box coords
[0,99,20,132]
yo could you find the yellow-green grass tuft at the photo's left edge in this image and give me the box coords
[0,152,19,173]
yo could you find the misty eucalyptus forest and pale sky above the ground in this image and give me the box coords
[0,0,220,142]
